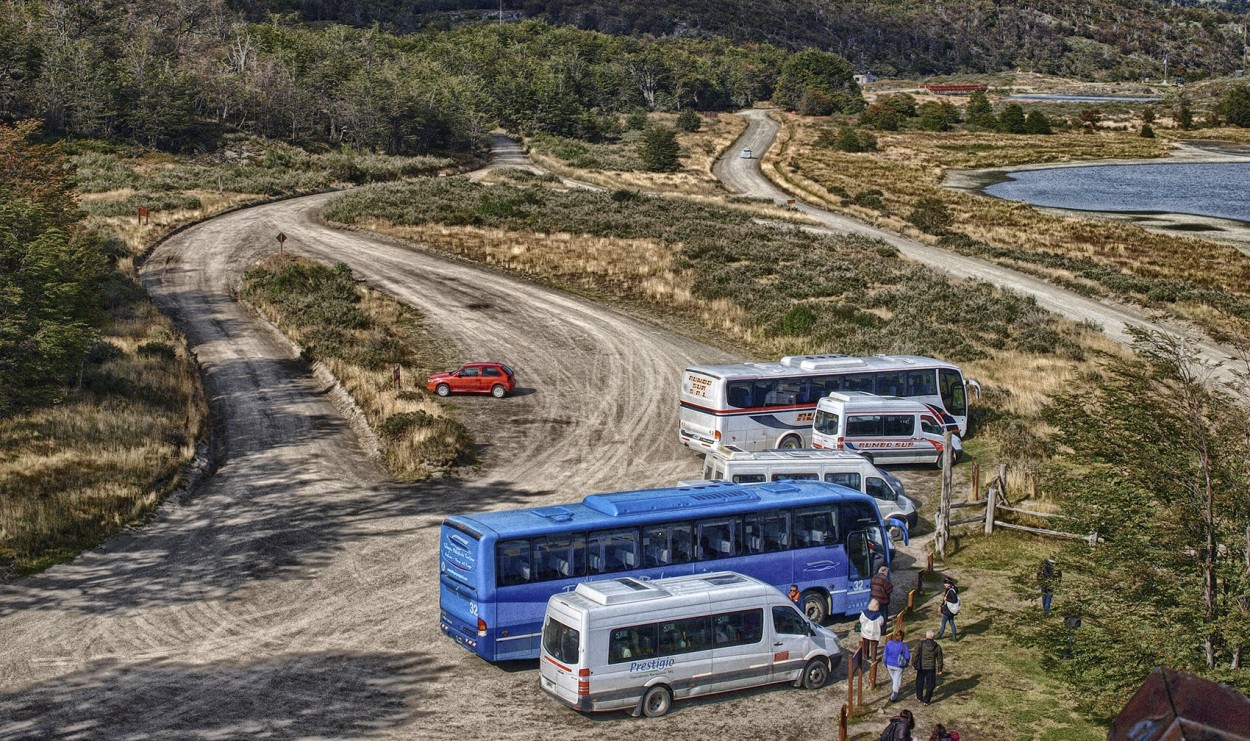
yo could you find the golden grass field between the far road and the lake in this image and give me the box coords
[766,116,1250,337]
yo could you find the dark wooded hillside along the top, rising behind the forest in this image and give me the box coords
[230,0,1244,80]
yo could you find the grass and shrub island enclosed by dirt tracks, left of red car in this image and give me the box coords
[241,256,474,481]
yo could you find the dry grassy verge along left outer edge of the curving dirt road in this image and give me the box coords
[0,139,451,579]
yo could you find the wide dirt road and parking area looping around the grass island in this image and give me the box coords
[0,177,910,739]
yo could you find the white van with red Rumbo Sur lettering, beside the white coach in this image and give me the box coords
[811,391,964,466]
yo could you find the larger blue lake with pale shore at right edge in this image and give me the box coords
[985,160,1250,222]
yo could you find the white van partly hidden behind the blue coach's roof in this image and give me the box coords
[704,445,918,531]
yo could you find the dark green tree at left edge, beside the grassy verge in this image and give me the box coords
[0,122,104,415]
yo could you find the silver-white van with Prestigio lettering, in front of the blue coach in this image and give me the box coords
[539,571,843,717]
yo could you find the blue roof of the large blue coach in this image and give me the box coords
[448,481,875,537]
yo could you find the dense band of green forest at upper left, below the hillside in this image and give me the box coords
[0,0,790,154]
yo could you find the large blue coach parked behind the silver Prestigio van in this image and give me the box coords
[439,481,906,661]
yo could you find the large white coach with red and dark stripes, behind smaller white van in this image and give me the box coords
[679,355,980,452]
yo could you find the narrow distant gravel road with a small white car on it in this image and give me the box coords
[713,109,1234,382]
